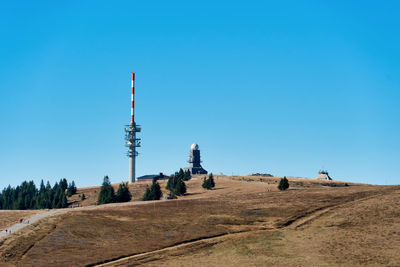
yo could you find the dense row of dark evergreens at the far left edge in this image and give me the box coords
[0,178,76,210]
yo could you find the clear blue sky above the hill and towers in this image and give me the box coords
[0,0,400,188]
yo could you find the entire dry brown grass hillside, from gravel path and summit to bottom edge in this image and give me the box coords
[0,176,400,266]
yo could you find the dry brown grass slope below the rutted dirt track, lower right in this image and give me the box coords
[151,190,400,266]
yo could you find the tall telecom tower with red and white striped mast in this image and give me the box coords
[125,72,141,183]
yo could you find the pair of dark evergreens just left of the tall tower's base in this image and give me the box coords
[97,176,132,205]
